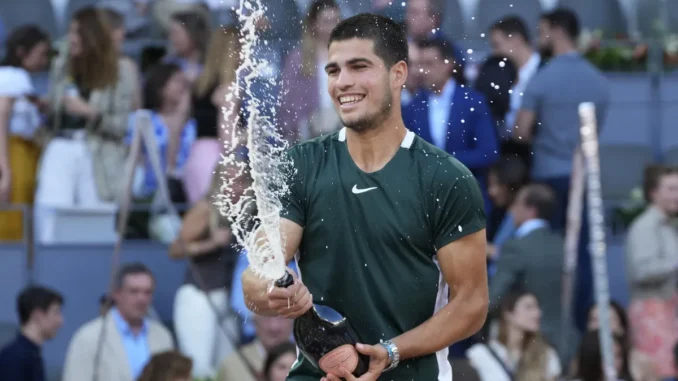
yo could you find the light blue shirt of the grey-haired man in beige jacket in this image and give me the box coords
[111,308,151,380]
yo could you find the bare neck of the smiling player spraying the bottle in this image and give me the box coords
[346,114,407,173]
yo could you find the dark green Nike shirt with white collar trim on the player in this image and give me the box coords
[282,129,485,381]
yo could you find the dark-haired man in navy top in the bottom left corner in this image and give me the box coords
[0,286,64,381]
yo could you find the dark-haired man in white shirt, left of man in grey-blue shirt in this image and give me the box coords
[490,16,541,137]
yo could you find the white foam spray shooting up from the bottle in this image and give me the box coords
[216,0,293,280]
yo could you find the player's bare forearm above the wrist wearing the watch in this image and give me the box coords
[393,292,488,359]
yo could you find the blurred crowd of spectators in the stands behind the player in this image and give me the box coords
[0,0,678,381]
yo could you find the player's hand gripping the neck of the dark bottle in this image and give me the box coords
[268,269,313,319]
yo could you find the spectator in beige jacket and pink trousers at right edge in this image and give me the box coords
[626,166,678,377]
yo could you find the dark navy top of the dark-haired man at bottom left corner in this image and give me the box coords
[0,334,45,381]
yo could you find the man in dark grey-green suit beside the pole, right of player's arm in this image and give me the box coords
[490,184,567,356]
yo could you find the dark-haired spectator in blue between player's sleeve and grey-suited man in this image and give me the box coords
[487,156,527,268]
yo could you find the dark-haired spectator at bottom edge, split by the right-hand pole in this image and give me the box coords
[574,331,634,381]
